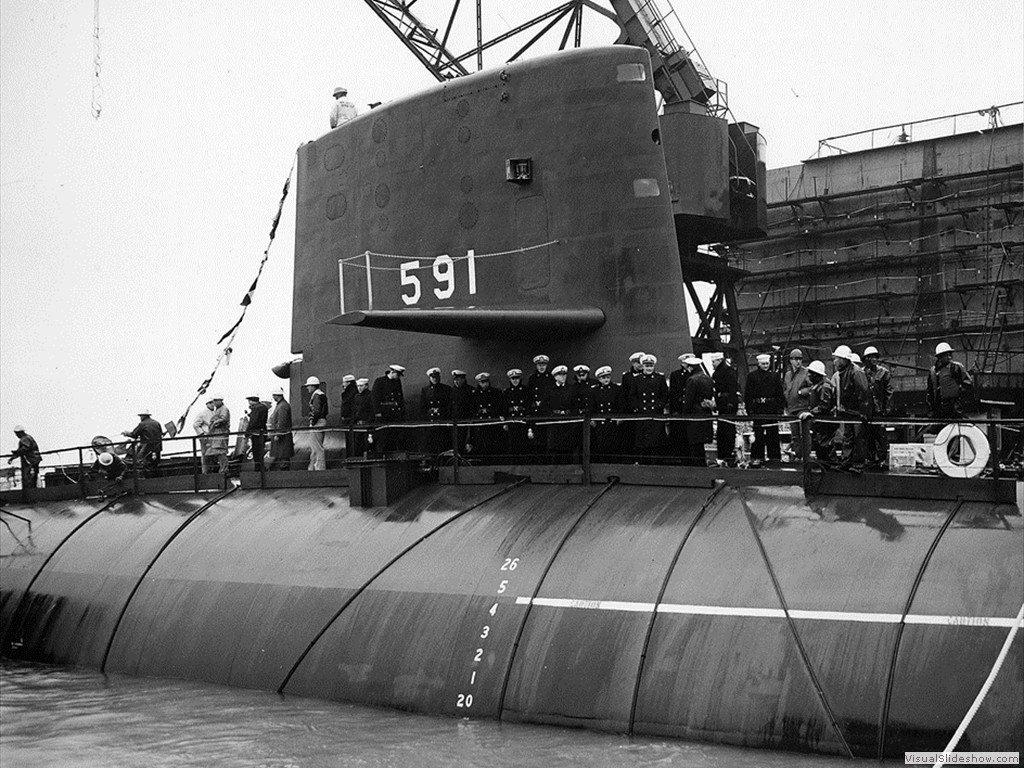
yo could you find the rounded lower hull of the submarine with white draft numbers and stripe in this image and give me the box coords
[0,484,1024,758]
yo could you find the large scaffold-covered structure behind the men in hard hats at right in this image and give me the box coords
[722,103,1024,412]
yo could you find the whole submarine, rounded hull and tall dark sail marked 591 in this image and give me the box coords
[0,41,1024,759]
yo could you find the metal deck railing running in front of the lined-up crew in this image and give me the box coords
[0,414,1024,498]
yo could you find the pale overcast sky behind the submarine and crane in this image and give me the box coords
[0,0,1024,458]
